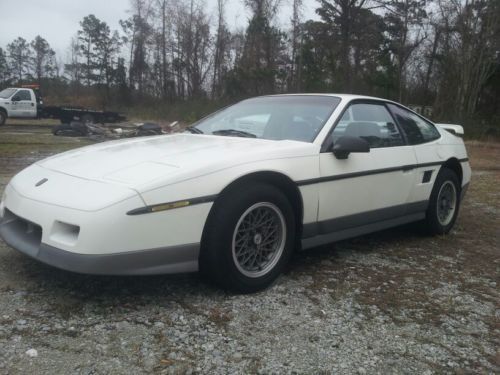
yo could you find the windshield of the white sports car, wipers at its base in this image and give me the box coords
[190,95,340,142]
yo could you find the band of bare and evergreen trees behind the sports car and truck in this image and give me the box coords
[0,0,500,135]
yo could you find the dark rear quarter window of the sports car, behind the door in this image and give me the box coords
[389,104,440,145]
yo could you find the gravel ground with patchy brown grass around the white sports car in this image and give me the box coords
[0,125,500,374]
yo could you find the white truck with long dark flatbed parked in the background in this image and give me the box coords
[0,85,125,125]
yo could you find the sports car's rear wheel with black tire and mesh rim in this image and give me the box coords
[425,167,460,234]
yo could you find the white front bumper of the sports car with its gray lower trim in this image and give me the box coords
[0,185,212,275]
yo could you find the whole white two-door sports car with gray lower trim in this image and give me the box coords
[0,94,471,292]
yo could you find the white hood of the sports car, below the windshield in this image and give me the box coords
[37,134,318,190]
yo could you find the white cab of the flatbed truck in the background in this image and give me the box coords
[0,87,39,125]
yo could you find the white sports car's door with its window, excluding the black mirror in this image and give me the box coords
[318,101,416,238]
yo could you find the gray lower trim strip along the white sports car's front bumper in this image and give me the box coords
[0,214,200,275]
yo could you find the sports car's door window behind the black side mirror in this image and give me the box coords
[332,103,404,148]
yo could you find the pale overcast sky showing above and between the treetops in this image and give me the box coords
[0,0,317,59]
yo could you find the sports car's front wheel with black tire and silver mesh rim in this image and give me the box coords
[199,183,295,293]
